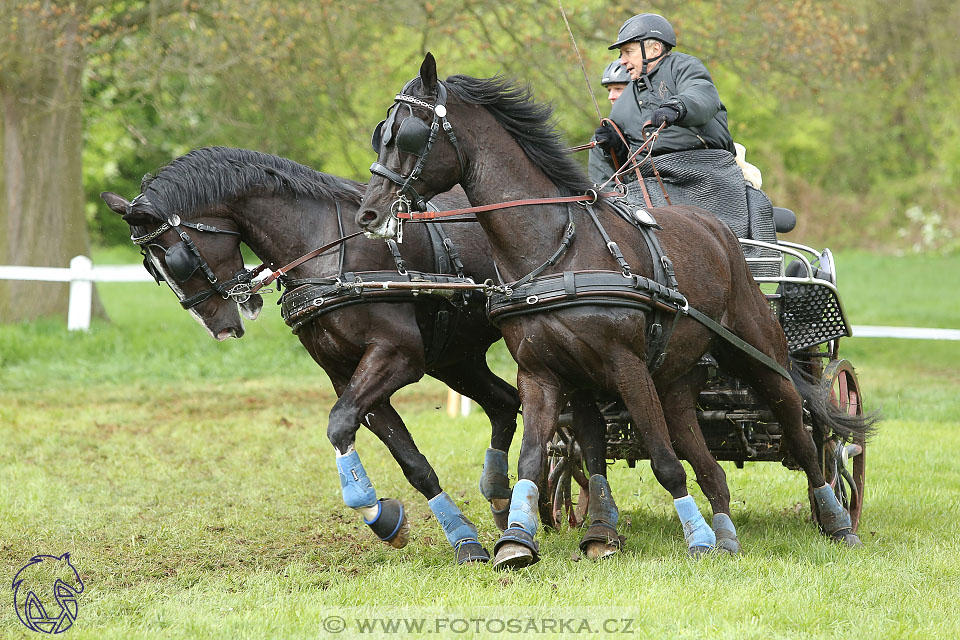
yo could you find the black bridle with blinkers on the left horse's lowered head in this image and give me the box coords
[130,199,255,309]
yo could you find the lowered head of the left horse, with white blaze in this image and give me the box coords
[100,191,263,340]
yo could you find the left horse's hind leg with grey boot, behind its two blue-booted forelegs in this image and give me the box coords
[430,355,520,531]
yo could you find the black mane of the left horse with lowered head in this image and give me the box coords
[140,147,363,219]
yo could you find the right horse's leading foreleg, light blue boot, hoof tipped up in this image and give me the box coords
[493,376,563,569]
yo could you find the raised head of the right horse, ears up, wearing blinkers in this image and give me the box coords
[357,53,465,238]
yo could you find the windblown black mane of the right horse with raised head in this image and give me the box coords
[444,75,593,194]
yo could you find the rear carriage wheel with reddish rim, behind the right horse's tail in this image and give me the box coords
[810,360,867,531]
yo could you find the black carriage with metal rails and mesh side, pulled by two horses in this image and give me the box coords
[540,212,866,531]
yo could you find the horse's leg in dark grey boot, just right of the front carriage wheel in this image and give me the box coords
[570,392,624,559]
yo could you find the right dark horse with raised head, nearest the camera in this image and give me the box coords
[358,54,867,567]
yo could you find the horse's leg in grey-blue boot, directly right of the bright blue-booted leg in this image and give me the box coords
[660,367,740,553]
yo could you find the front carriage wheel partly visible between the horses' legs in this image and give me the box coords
[540,427,590,529]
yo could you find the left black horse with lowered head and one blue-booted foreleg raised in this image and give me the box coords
[101,148,520,562]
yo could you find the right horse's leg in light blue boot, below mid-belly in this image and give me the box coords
[616,360,717,556]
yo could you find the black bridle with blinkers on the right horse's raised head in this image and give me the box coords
[370,78,465,214]
